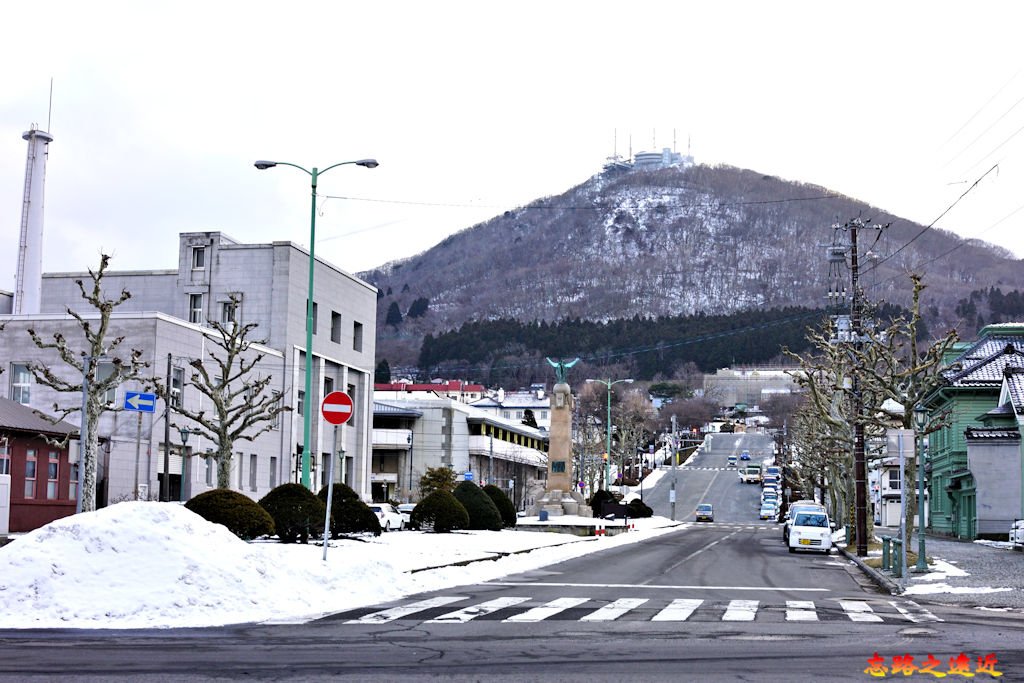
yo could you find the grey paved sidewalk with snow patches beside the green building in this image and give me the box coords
[845,527,1024,612]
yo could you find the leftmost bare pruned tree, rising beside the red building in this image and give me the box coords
[28,254,150,512]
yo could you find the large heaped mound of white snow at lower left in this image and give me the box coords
[0,502,412,628]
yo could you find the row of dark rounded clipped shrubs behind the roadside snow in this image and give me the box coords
[185,481,516,543]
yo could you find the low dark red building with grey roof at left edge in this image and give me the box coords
[0,398,78,532]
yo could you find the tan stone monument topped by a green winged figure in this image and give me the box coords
[535,358,591,518]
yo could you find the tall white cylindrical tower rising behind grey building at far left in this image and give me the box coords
[11,126,53,314]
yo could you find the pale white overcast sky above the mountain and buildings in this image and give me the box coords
[0,0,1024,291]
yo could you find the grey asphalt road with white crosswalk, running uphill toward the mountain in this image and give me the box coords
[0,436,1024,682]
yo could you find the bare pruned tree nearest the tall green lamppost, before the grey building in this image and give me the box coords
[153,297,292,488]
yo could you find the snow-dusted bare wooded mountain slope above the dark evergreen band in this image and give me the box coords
[359,166,1024,376]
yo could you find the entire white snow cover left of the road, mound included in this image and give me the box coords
[0,502,681,629]
